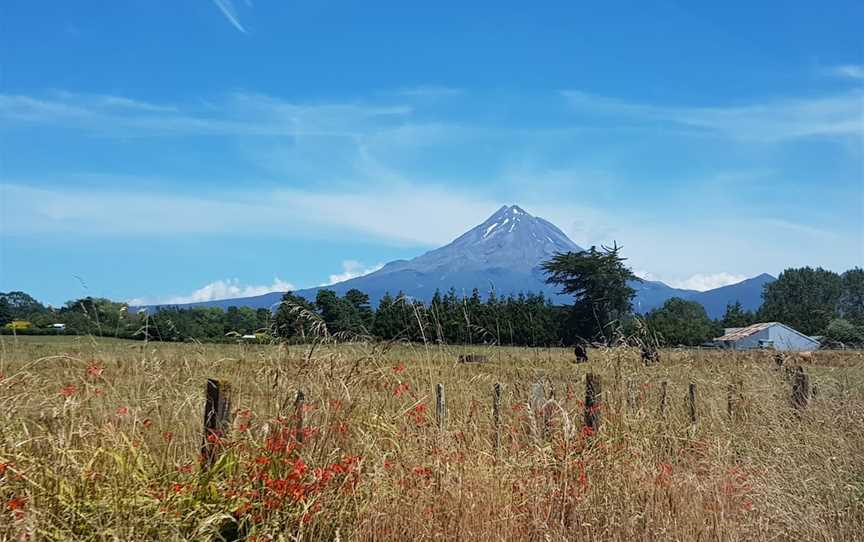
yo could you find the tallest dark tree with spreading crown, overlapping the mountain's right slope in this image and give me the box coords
[542,245,640,344]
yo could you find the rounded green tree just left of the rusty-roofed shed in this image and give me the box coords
[646,297,718,346]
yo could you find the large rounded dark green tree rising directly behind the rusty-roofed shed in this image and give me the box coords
[759,267,843,335]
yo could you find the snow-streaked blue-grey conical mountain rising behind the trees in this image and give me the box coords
[143,205,774,318]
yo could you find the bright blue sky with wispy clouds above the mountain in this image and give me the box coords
[0,0,864,304]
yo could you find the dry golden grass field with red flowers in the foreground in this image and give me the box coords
[0,337,864,541]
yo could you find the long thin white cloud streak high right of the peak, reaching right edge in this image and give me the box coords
[562,91,864,142]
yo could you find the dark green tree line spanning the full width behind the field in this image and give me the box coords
[0,250,864,346]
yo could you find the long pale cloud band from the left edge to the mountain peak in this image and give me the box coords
[0,184,501,246]
